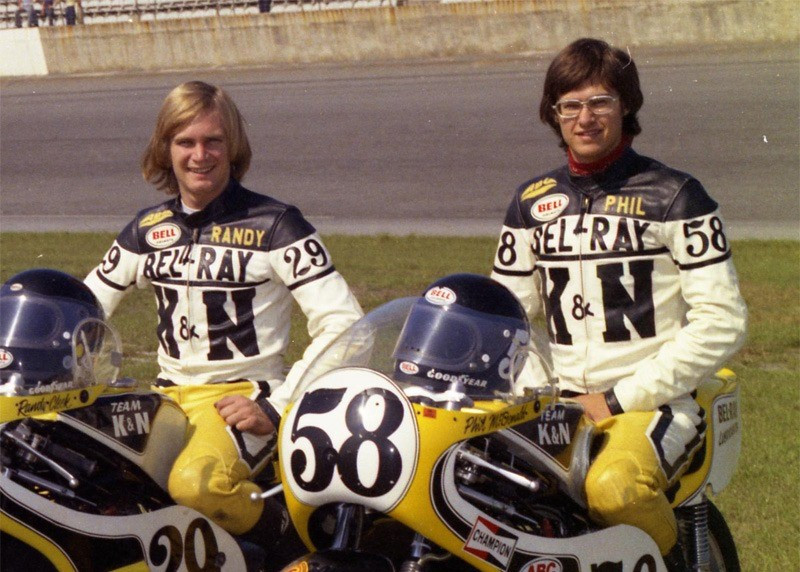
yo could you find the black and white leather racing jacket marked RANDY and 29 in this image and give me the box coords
[86,180,362,412]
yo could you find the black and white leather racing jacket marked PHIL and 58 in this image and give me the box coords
[492,148,746,413]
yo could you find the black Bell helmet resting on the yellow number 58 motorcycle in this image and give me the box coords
[393,274,530,399]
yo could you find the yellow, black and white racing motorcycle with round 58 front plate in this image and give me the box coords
[279,298,741,572]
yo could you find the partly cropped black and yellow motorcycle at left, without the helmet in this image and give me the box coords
[0,380,262,572]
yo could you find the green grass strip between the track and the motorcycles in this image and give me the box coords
[0,233,800,571]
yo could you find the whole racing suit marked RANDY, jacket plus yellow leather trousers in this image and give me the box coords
[85,179,362,534]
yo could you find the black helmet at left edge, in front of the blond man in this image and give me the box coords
[0,269,121,395]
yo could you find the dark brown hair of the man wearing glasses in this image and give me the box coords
[539,38,644,148]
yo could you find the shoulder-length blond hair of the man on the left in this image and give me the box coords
[141,81,253,195]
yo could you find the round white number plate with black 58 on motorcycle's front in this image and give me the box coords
[280,368,419,512]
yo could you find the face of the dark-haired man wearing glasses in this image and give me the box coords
[558,84,624,163]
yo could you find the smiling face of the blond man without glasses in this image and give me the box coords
[169,110,231,209]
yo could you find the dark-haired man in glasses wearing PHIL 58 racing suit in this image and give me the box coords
[492,39,747,570]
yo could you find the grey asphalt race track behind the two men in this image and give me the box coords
[0,45,800,239]
